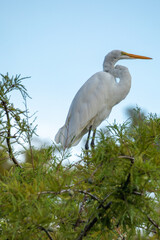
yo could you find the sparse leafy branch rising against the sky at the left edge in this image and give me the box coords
[0,74,35,167]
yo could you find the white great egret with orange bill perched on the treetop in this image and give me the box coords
[55,50,151,149]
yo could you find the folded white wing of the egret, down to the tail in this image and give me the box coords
[55,72,115,147]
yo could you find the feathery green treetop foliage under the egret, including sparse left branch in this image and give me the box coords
[0,75,160,240]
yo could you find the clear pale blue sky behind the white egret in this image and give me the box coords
[0,0,160,153]
